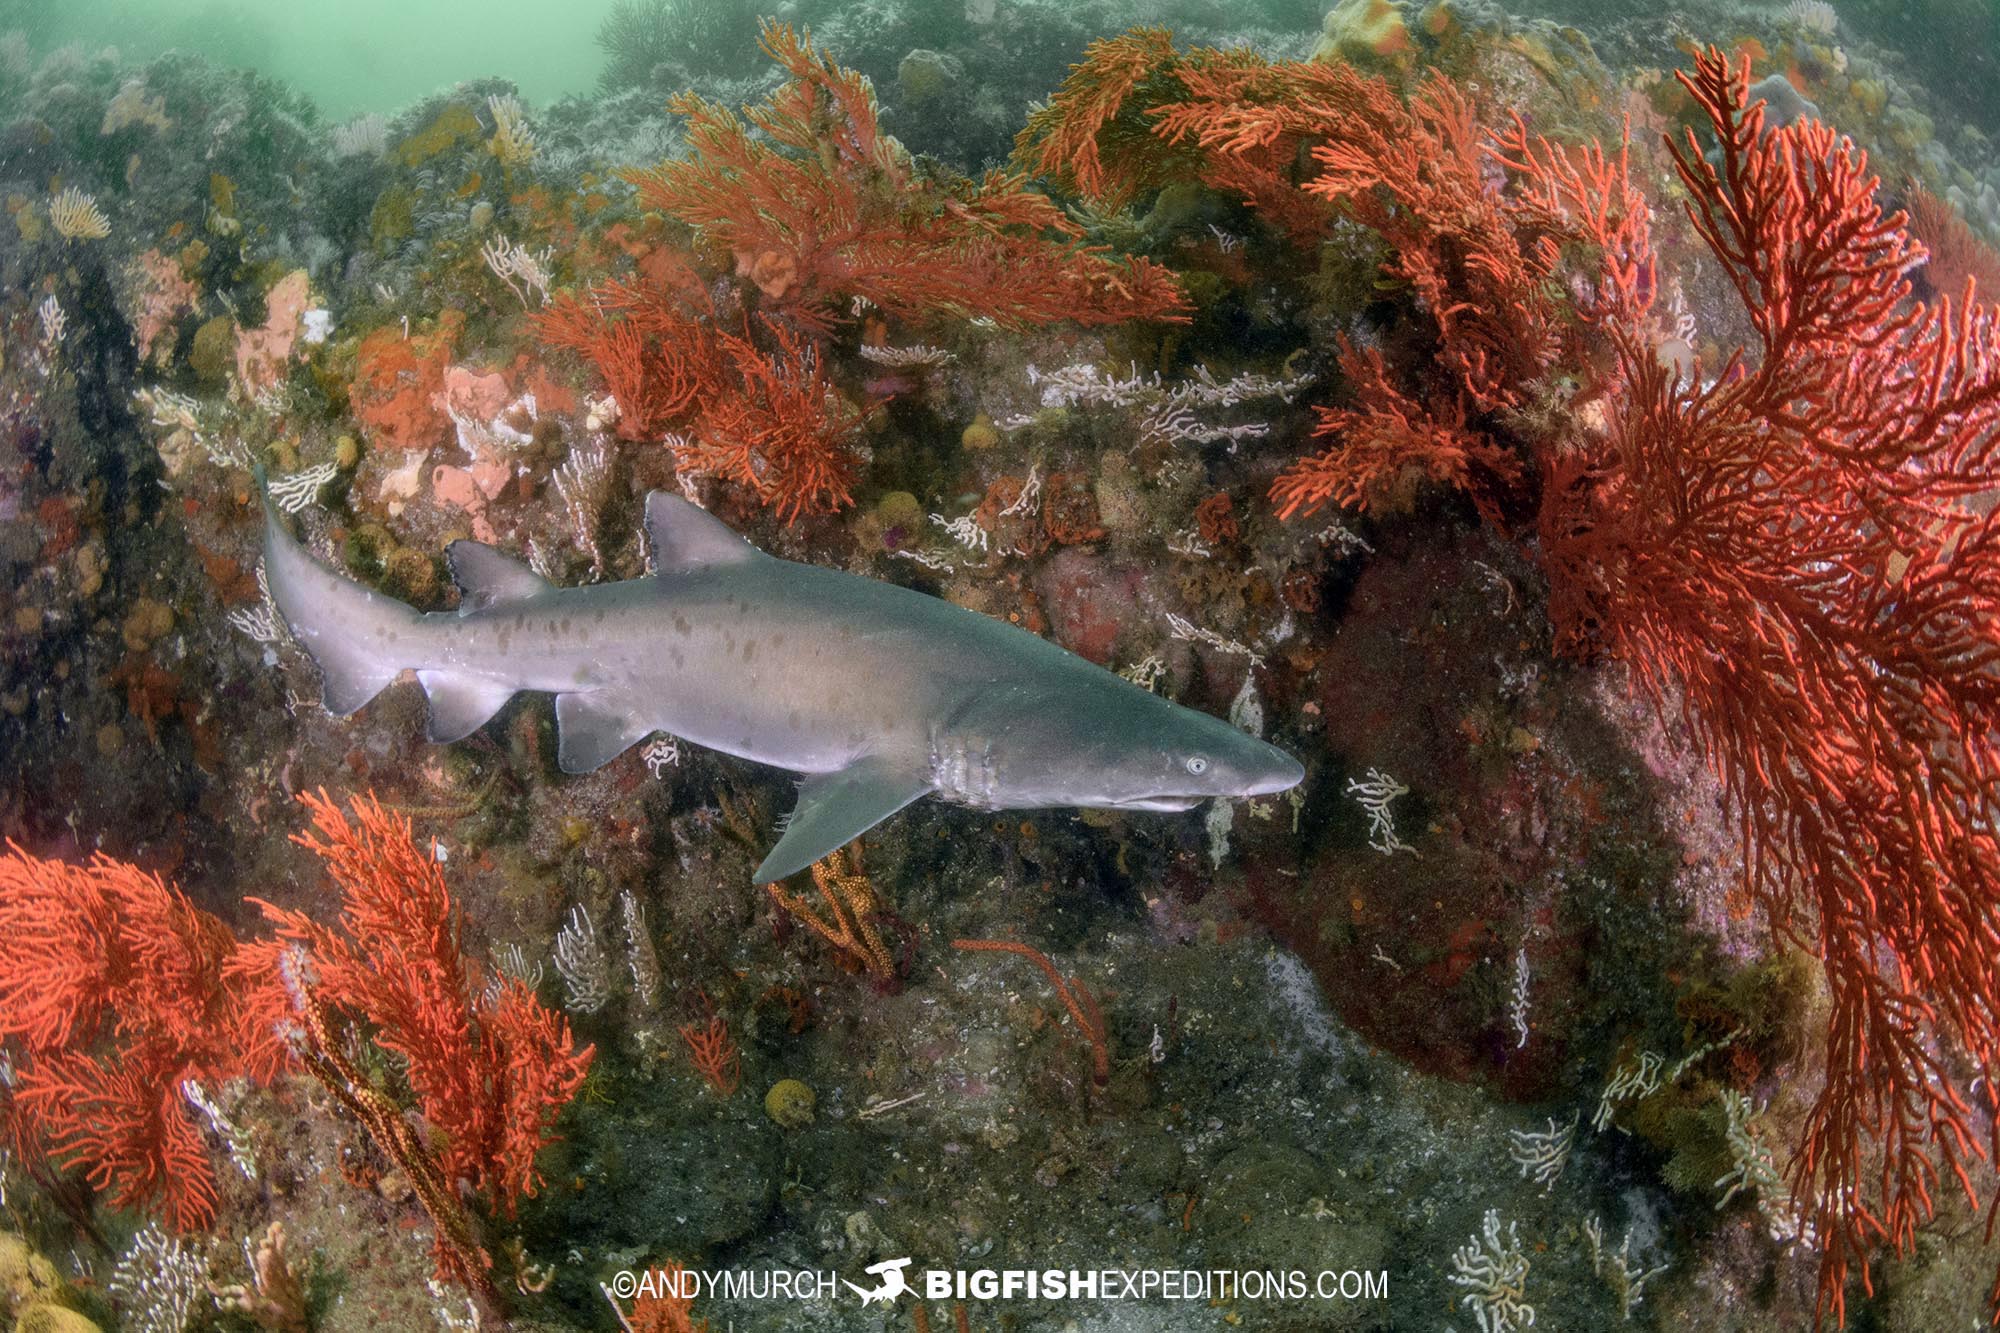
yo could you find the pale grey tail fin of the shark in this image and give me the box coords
[256,468,424,717]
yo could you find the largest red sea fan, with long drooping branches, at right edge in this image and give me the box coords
[1540,50,2000,1317]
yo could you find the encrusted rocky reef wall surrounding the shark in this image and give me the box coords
[0,0,2000,1333]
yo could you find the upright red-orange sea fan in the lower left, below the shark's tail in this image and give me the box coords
[230,793,594,1281]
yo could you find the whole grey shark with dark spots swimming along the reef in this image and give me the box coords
[264,490,1306,885]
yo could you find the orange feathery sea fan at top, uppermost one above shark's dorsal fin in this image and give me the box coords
[628,22,1188,330]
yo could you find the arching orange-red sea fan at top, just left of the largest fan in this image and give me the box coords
[1016,32,1652,518]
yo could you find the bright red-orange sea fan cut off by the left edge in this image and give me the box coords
[0,843,274,1231]
